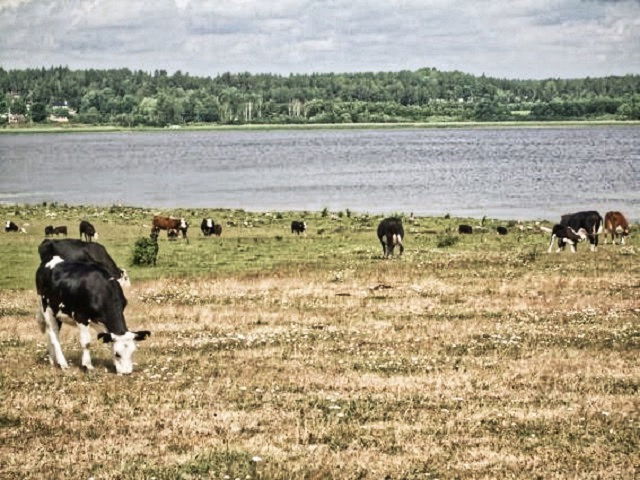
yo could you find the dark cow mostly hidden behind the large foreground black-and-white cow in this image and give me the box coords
[38,238,131,287]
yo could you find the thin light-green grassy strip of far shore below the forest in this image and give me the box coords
[0,120,640,134]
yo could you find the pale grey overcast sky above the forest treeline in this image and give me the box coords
[0,0,640,78]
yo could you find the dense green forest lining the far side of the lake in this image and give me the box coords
[0,67,640,127]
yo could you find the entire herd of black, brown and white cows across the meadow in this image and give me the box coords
[0,210,629,374]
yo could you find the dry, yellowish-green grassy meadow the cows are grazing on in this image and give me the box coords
[0,205,640,480]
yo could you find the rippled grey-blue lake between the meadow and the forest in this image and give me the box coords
[0,126,640,220]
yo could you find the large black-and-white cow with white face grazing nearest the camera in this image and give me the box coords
[36,256,151,374]
